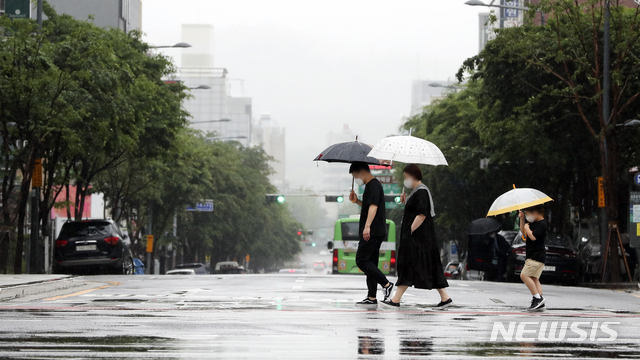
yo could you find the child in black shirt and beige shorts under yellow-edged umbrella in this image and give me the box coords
[518,205,547,311]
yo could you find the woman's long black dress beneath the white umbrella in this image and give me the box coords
[396,189,449,290]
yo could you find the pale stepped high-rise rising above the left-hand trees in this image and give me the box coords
[174,24,252,146]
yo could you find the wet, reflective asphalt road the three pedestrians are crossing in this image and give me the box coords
[0,275,640,360]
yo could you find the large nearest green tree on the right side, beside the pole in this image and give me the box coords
[459,0,640,281]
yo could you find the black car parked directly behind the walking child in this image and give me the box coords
[507,233,581,285]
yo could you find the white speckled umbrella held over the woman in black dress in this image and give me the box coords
[368,135,449,165]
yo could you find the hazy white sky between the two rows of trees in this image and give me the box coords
[142,0,486,187]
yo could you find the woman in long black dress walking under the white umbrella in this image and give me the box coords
[384,164,453,308]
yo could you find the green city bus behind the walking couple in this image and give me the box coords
[330,216,396,276]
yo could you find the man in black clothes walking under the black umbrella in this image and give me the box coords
[349,162,393,305]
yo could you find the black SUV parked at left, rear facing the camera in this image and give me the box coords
[53,219,133,275]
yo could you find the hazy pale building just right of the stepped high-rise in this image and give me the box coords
[251,114,287,189]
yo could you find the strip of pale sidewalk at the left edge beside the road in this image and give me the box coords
[0,275,84,301]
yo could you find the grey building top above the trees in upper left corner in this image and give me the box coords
[30,0,142,32]
